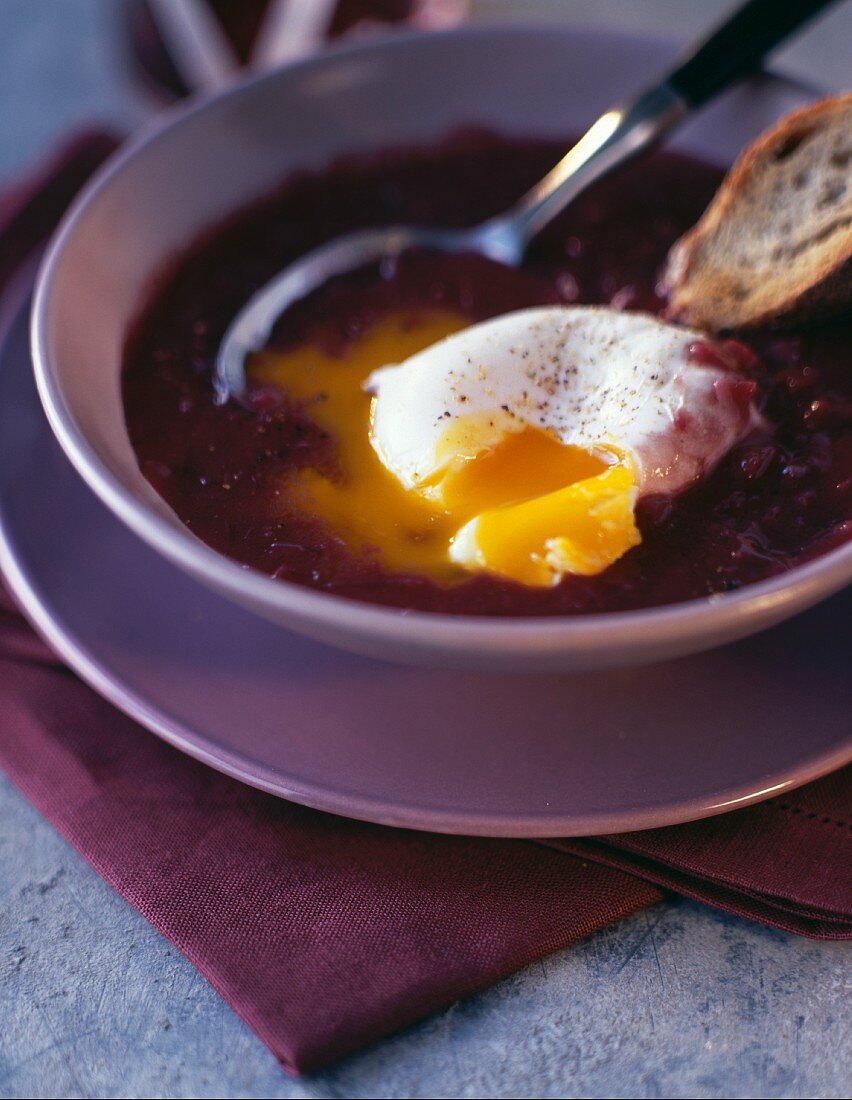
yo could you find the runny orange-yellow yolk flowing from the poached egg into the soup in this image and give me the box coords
[250,312,640,586]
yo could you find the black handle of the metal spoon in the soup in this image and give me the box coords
[668,0,837,107]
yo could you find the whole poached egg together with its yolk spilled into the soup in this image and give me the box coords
[251,307,759,586]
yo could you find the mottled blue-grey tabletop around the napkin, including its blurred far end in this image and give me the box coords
[0,0,852,1097]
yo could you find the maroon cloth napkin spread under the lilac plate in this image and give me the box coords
[0,134,852,1073]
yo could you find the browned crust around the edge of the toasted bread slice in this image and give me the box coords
[663,92,852,331]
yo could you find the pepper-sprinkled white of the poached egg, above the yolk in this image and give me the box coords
[365,307,760,496]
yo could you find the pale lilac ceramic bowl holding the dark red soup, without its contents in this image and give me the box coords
[33,26,852,671]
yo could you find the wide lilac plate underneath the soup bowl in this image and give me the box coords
[0,297,852,837]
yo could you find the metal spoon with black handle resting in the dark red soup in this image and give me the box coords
[213,0,834,404]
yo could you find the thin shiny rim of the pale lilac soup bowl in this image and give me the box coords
[30,21,852,653]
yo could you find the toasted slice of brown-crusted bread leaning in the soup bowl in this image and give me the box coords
[663,92,852,332]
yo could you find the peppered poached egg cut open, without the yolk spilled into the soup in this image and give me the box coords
[365,307,760,585]
